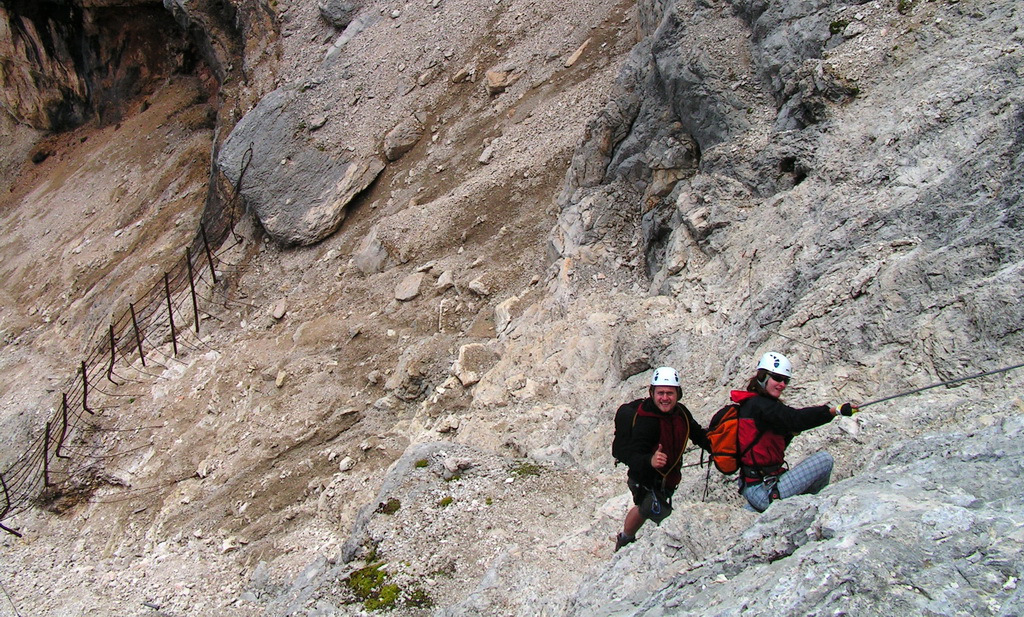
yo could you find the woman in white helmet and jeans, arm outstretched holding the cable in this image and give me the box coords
[731,351,857,512]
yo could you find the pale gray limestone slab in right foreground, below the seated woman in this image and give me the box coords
[570,416,1024,617]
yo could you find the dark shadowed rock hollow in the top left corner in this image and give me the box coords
[0,1,193,131]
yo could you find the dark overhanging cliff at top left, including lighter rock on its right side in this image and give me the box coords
[0,0,276,132]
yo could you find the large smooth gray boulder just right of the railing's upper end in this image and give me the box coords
[217,88,384,246]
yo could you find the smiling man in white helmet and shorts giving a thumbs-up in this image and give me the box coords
[612,366,711,550]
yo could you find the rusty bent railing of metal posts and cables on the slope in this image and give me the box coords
[0,166,253,536]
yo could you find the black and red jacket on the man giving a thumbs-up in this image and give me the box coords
[626,398,711,490]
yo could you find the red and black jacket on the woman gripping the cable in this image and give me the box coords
[731,390,833,482]
